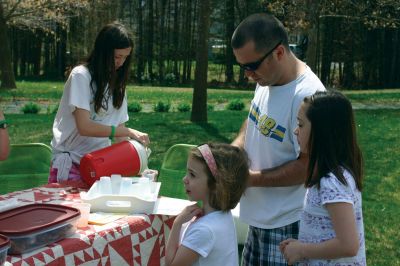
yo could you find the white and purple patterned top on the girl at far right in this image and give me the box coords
[299,170,367,266]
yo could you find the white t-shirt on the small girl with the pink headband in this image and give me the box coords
[180,211,239,266]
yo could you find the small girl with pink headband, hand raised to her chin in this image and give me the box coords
[165,143,249,265]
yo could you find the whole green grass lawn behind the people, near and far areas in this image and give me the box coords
[0,83,400,265]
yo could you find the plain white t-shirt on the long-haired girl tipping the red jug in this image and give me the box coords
[51,65,129,164]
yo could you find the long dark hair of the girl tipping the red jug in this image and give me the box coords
[85,22,133,113]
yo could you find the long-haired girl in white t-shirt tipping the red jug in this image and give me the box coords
[49,22,149,185]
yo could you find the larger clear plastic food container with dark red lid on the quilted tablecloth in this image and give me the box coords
[0,204,80,254]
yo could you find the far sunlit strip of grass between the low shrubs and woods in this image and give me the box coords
[0,81,400,113]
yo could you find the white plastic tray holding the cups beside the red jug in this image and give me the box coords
[80,181,161,214]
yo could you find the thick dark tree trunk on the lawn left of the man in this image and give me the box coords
[190,0,210,122]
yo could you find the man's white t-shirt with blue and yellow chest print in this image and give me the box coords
[240,67,325,229]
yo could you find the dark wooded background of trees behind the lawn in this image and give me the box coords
[0,0,400,89]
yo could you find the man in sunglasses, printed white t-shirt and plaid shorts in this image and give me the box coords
[231,14,325,265]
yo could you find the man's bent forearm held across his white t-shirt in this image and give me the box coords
[248,153,308,187]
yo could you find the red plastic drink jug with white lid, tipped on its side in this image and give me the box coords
[79,140,148,186]
